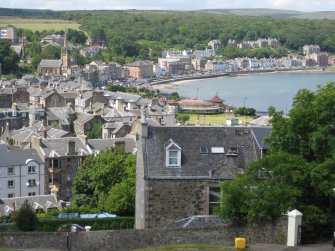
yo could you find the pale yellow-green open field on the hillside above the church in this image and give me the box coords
[0,17,80,32]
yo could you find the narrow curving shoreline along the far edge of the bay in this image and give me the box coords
[149,67,335,89]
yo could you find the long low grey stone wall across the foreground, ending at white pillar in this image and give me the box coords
[0,217,287,251]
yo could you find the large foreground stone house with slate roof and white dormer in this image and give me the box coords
[135,114,272,229]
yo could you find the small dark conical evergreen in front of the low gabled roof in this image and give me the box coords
[15,200,38,232]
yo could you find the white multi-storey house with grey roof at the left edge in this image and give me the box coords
[0,144,46,198]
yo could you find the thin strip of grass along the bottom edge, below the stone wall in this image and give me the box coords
[134,244,236,251]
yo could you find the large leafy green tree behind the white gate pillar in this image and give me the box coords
[218,82,335,241]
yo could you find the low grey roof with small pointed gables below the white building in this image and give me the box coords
[0,194,62,214]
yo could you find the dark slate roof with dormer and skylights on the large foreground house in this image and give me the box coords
[144,126,268,179]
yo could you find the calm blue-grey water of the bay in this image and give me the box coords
[161,72,335,112]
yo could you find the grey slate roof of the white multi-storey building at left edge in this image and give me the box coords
[0,144,44,166]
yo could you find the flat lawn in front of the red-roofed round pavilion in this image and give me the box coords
[186,114,253,125]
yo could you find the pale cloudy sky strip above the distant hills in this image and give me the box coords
[0,0,335,11]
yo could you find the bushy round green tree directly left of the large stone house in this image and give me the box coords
[71,147,135,215]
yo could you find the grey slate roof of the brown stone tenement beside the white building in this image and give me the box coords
[41,137,90,157]
